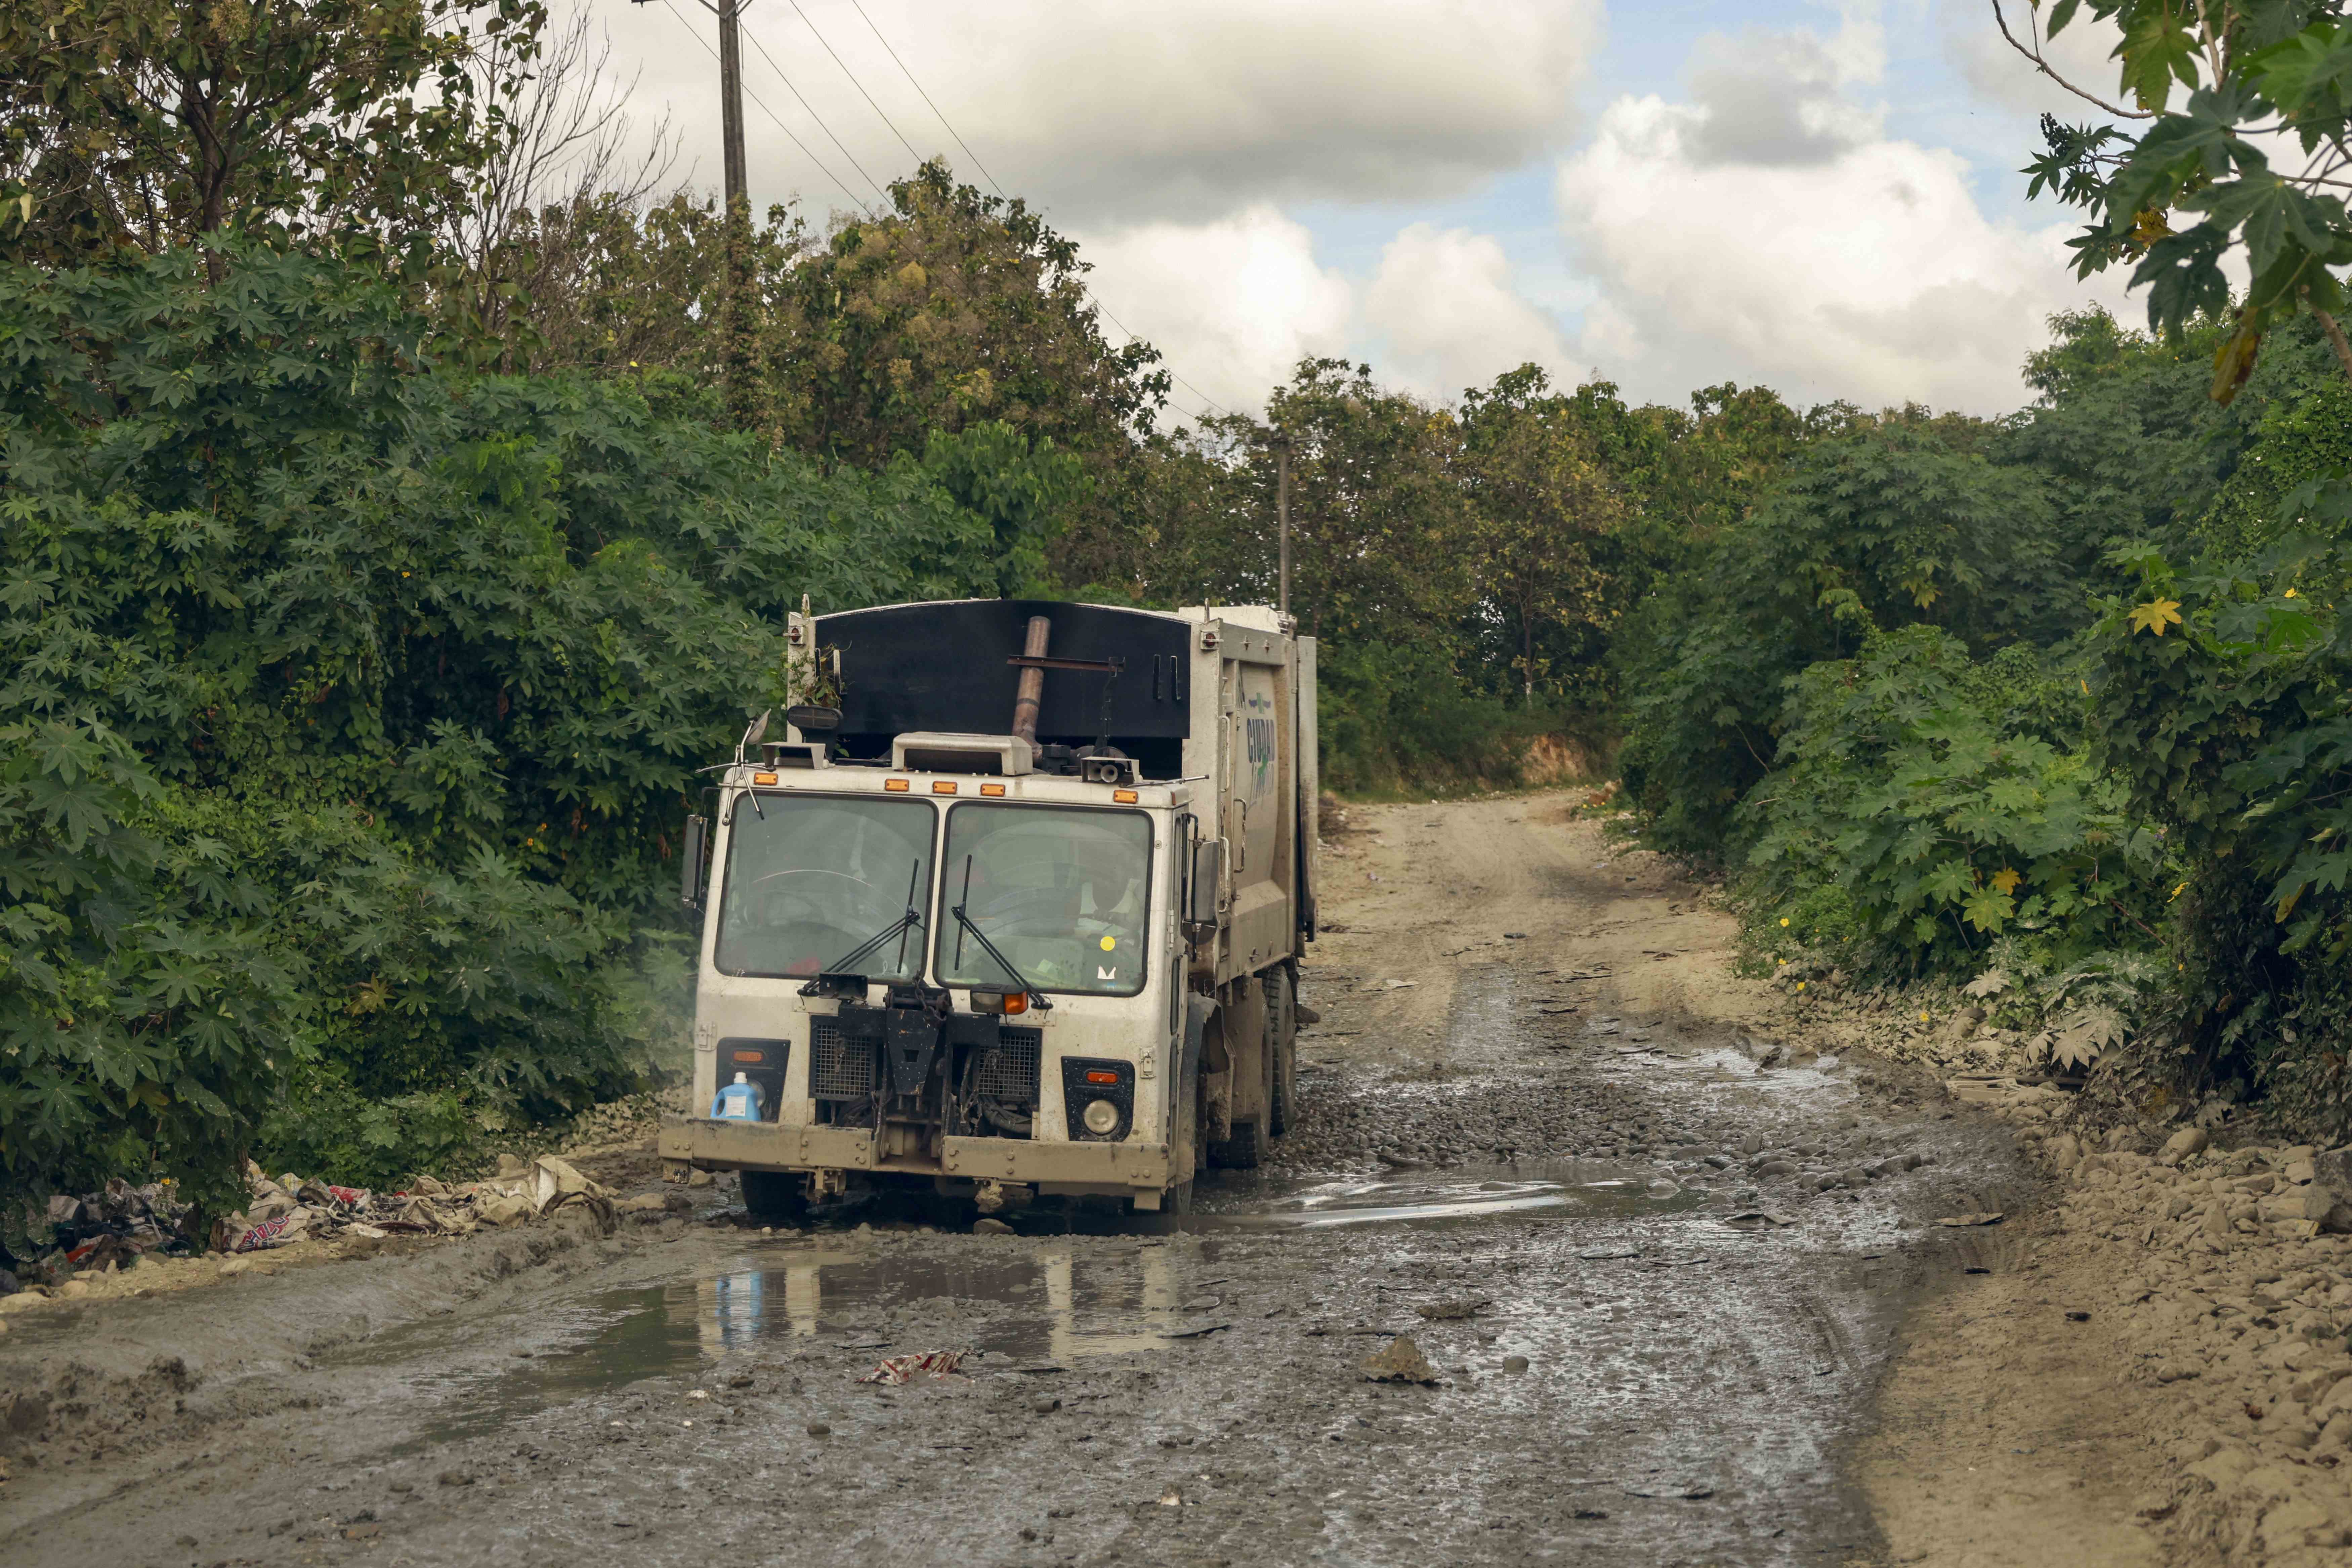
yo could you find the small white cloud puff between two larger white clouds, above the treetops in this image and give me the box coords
[1362,223,1576,399]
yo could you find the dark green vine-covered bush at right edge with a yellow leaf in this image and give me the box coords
[2093,534,2352,1136]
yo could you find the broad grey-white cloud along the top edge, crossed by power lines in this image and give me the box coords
[597,0,1602,228]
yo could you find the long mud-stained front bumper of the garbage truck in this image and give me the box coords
[656,1117,1169,1194]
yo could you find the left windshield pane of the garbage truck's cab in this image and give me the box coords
[713,795,934,980]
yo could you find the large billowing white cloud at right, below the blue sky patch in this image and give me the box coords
[1557,96,2119,414]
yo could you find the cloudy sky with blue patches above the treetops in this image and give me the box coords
[593,0,2140,418]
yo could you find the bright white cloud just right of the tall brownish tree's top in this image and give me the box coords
[1080,202,1355,411]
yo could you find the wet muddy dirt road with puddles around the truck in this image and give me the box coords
[0,795,2025,1568]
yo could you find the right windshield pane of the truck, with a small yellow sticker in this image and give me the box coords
[936,804,1152,997]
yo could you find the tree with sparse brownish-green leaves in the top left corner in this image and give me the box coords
[0,0,546,266]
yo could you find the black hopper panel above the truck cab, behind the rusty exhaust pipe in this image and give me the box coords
[816,599,1195,780]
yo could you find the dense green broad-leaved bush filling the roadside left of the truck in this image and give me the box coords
[0,252,1035,1222]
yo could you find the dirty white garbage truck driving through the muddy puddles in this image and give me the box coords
[659,599,1317,1220]
